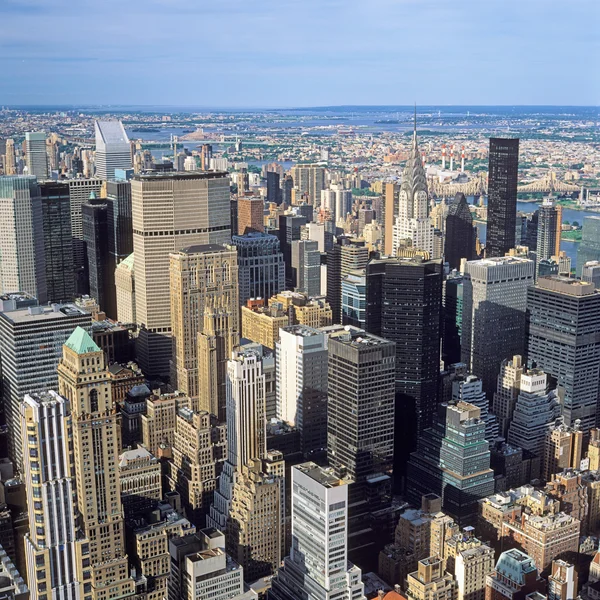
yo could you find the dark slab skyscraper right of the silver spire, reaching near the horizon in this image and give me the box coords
[485,138,519,258]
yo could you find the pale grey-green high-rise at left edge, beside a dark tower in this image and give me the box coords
[0,176,47,303]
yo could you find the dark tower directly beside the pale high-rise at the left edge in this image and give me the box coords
[40,181,75,302]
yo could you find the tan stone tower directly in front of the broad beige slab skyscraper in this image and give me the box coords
[170,244,240,398]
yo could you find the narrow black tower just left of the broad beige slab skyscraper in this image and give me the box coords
[81,199,117,318]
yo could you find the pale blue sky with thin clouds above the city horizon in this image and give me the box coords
[0,0,600,107]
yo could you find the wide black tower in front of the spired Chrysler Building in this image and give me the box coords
[366,258,443,473]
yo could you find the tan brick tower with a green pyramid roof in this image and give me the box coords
[58,327,135,600]
